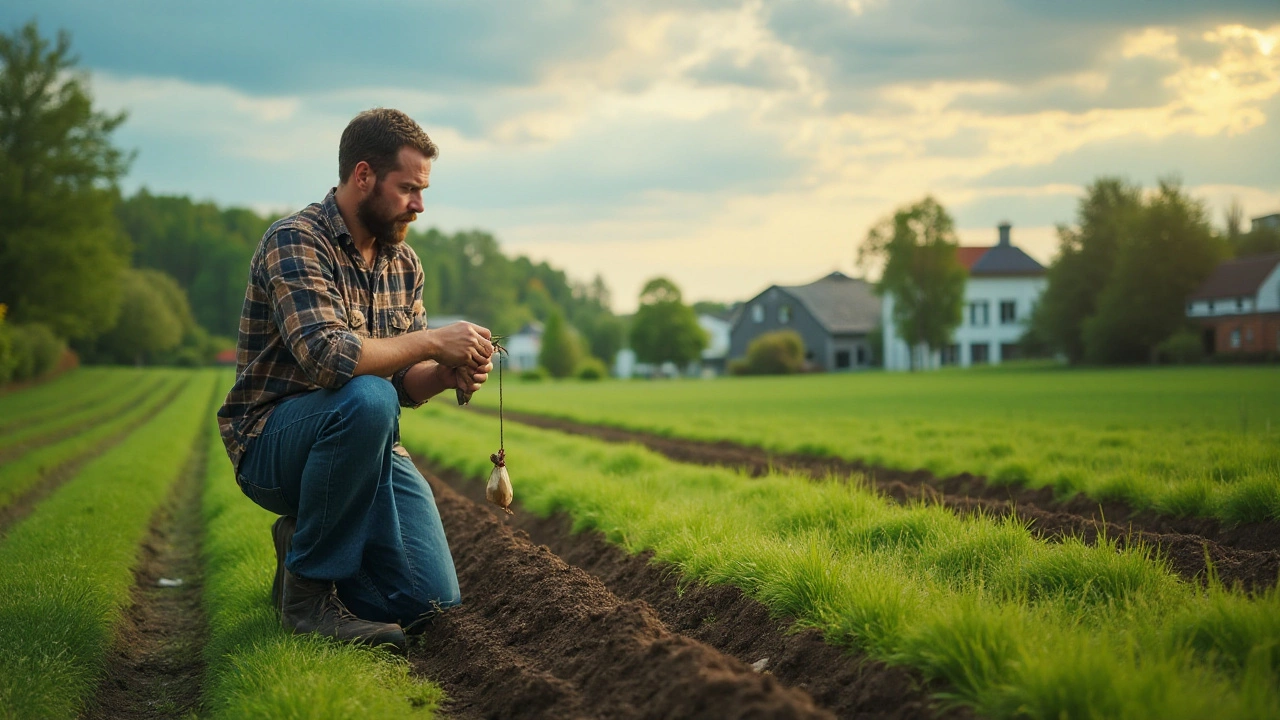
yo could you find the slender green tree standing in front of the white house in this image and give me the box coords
[858,196,965,369]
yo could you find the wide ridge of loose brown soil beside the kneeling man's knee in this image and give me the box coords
[410,466,831,719]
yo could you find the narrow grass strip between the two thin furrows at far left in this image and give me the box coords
[0,370,192,507]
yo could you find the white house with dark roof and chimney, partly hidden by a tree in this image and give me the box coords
[881,223,1047,370]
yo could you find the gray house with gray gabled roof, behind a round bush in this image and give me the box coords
[728,272,881,370]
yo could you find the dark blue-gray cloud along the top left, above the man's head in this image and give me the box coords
[0,0,627,95]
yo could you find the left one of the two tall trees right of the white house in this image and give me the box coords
[1029,177,1143,363]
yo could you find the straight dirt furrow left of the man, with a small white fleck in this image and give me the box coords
[82,399,209,720]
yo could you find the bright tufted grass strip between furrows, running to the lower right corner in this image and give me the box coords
[401,407,1280,719]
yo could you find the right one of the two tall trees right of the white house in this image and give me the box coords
[1083,179,1230,363]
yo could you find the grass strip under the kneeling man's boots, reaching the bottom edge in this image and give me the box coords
[204,371,444,720]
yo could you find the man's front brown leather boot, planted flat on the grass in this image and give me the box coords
[280,569,404,653]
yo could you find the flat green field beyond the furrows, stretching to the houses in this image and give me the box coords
[475,366,1280,521]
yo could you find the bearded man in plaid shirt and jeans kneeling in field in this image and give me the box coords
[218,109,493,651]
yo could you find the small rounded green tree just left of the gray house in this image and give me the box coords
[631,272,707,365]
